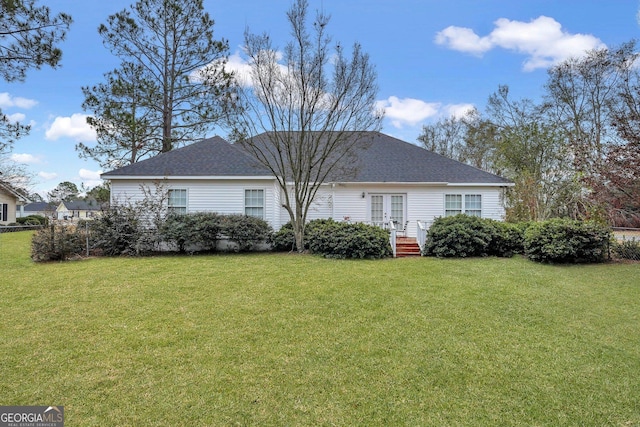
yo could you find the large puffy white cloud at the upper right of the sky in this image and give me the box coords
[435,16,605,71]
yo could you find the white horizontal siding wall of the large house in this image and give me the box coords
[111,180,505,237]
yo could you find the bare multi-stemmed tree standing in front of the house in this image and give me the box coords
[236,0,382,251]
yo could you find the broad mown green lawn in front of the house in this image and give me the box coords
[0,233,640,426]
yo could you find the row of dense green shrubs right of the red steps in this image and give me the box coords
[423,215,612,263]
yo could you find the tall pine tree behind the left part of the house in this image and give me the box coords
[78,0,234,166]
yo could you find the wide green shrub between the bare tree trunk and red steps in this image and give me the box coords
[306,219,393,259]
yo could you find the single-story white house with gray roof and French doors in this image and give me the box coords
[101,132,513,237]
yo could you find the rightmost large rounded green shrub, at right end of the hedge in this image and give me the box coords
[525,219,611,263]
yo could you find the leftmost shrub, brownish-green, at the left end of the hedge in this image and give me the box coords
[31,225,86,262]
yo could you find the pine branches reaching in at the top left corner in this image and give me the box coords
[0,0,72,153]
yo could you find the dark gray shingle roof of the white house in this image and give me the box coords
[102,132,511,185]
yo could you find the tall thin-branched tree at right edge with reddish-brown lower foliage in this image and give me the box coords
[546,42,640,225]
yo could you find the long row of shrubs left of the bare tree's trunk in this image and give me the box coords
[31,211,272,261]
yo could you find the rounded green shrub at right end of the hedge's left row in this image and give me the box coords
[220,214,272,252]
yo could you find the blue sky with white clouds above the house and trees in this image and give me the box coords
[0,0,640,196]
